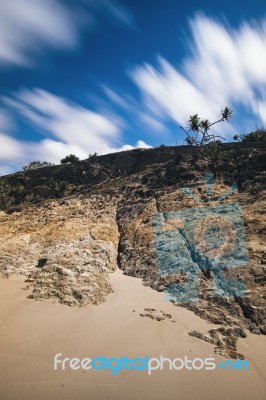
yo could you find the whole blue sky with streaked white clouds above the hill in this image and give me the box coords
[0,0,266,175]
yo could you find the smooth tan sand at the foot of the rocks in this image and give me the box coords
[0,270,266,400]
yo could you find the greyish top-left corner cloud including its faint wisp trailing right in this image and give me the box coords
[0,0,134,67]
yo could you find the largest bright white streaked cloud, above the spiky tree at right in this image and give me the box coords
[129,14,266,137]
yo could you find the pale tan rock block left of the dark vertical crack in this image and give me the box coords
[0,196,118,306]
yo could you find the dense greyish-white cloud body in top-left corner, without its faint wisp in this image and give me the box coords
[0,0,78,66]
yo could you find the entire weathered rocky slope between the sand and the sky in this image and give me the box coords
[0,144,266,338]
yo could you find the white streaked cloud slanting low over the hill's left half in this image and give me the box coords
[8,89,122,153]
